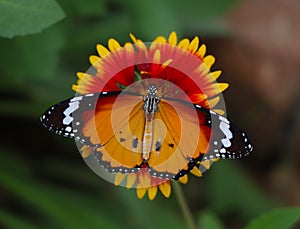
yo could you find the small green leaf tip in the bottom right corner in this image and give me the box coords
[245,207,300,229]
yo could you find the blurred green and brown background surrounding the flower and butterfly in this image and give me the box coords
[0,0,300,229]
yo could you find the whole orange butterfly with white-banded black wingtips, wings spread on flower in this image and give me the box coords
[40,82,253,180]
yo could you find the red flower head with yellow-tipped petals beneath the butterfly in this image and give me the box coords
[72,32,228,200]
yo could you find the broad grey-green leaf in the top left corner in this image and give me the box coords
[0,0,64,38]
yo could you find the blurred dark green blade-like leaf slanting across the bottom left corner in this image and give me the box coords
[0,150,121,229]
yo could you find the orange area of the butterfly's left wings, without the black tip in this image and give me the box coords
[82,94,144,168]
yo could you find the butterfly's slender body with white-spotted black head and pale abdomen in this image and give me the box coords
[142,86,159,160]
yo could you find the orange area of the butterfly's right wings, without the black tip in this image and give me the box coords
[148,100,210,174]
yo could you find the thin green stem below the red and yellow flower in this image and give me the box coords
[173,181,196,229]
